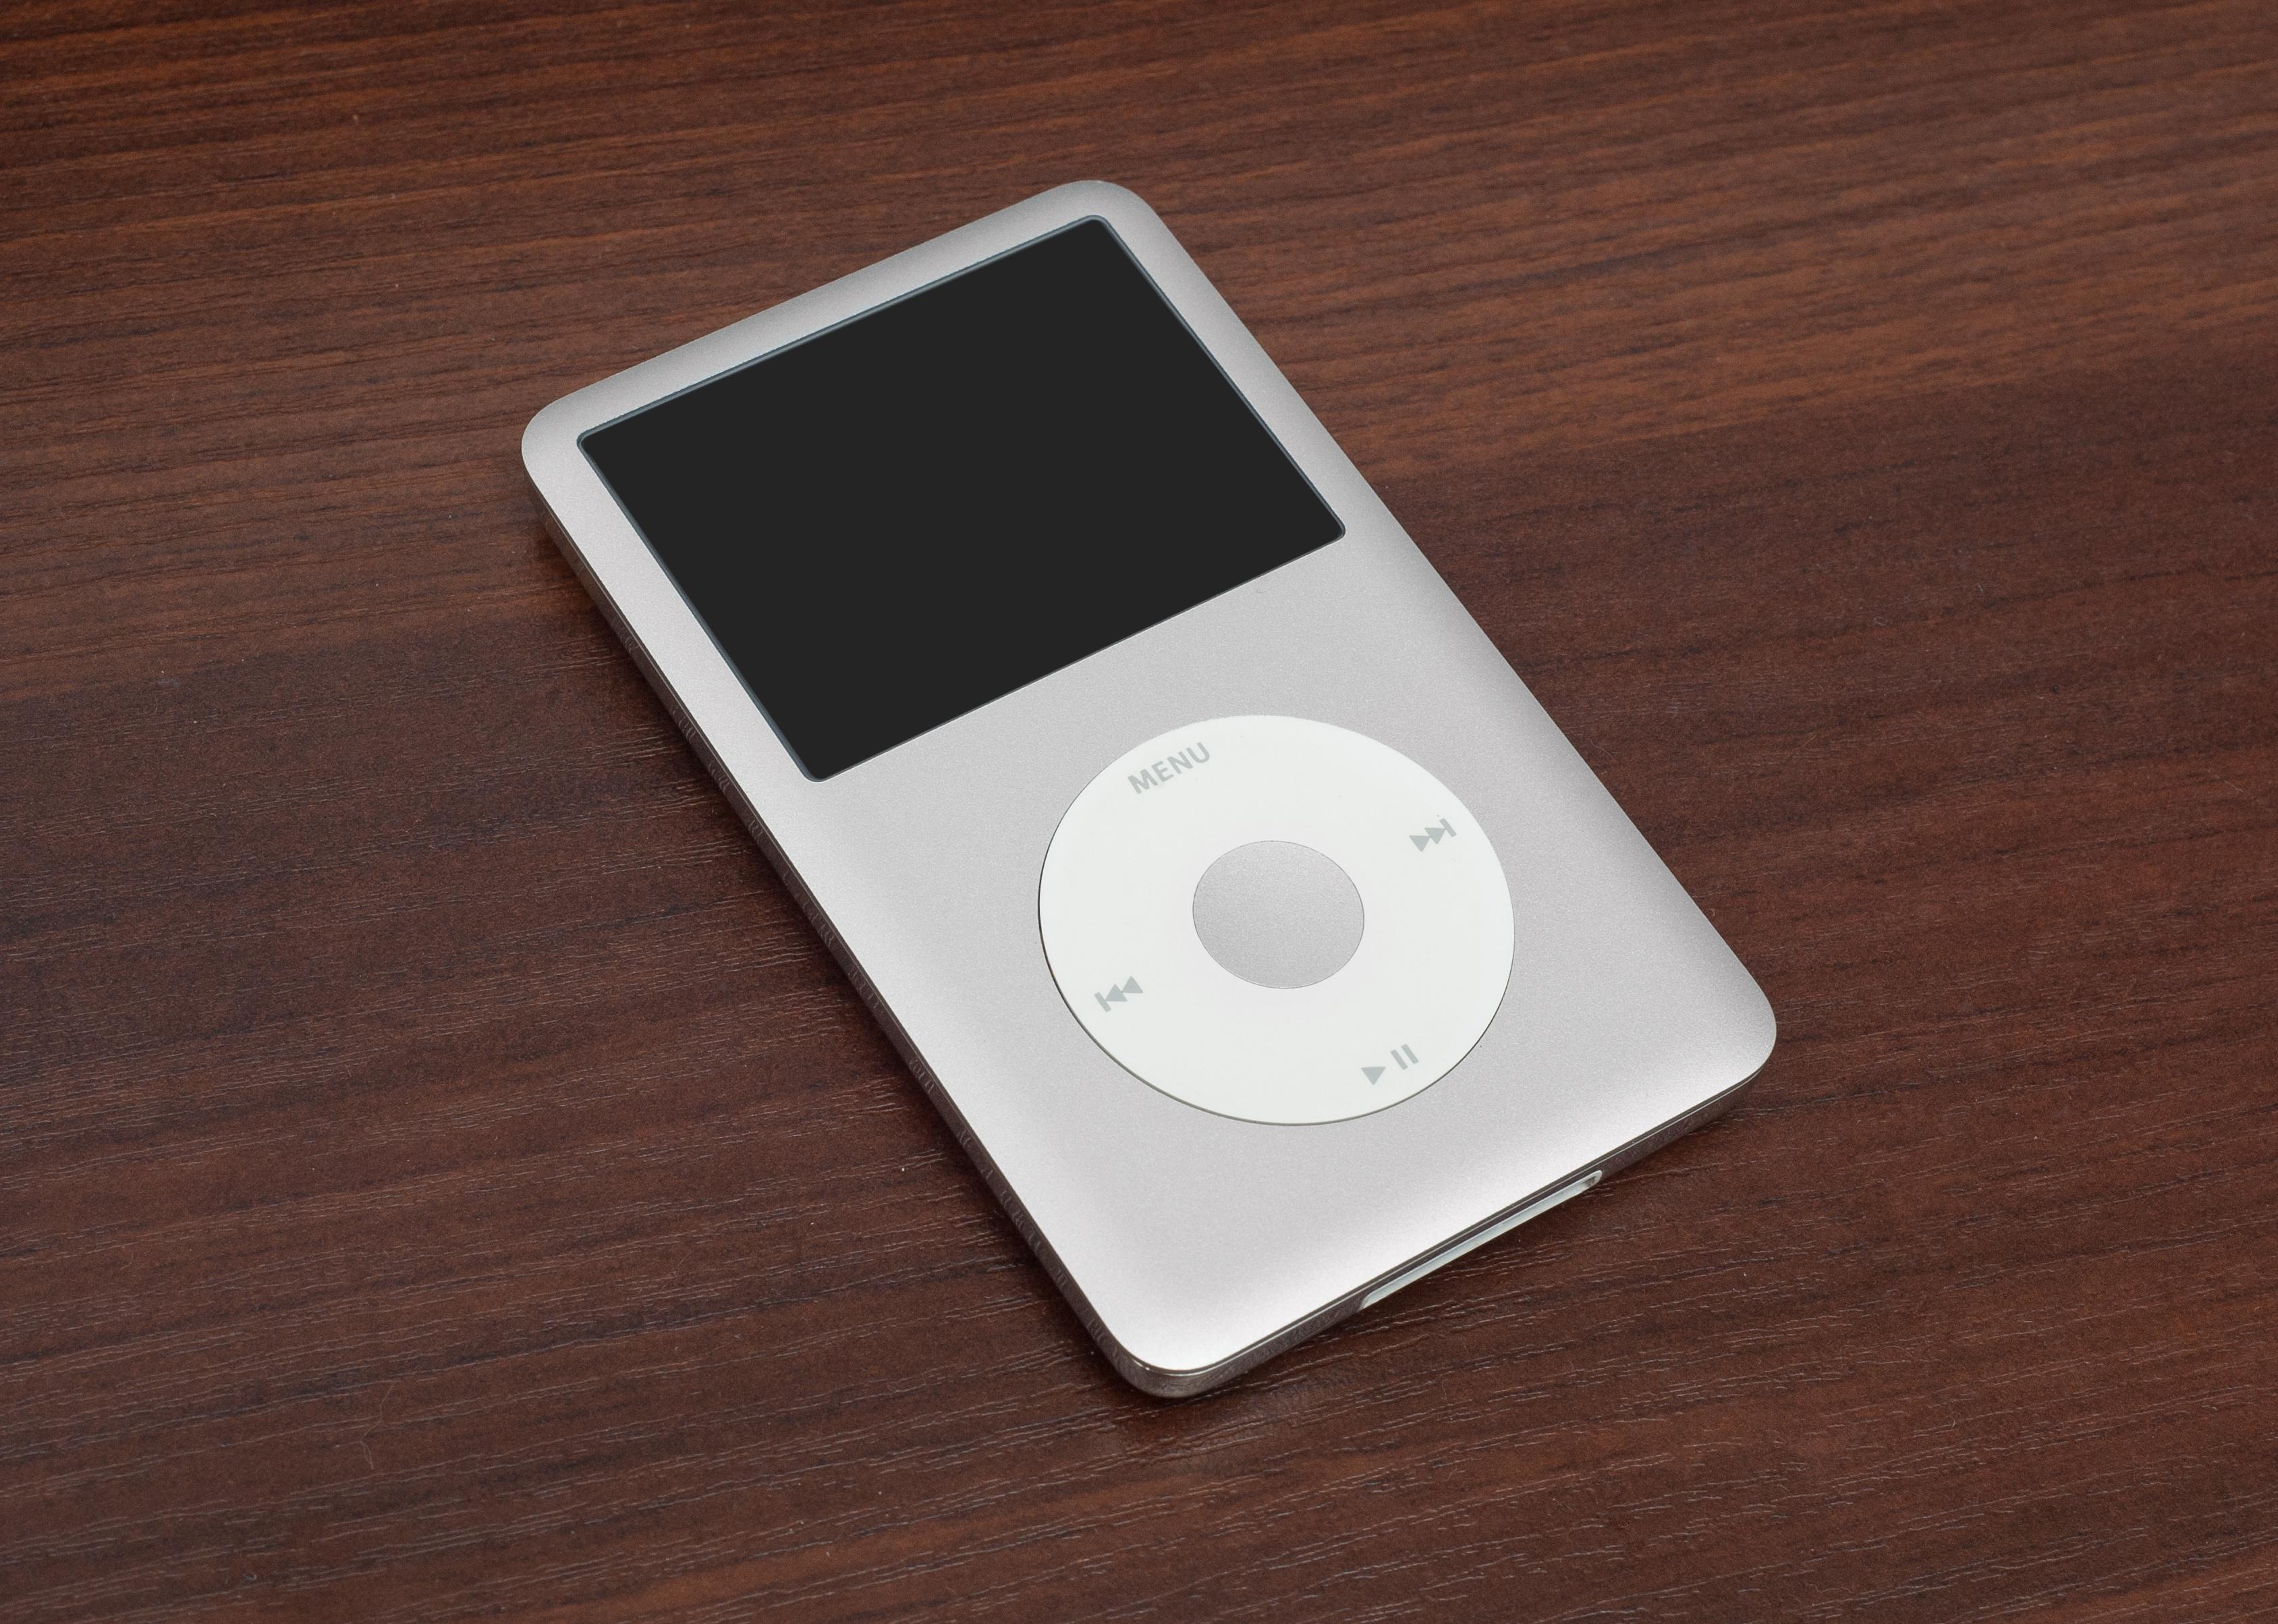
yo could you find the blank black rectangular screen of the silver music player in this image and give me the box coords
[583,221,1344,779]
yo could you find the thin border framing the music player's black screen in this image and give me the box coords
[576,212,1351,783]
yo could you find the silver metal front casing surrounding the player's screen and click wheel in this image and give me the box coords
[524,182,1775,1387]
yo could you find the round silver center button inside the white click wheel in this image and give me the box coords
[1194,841,1362,991]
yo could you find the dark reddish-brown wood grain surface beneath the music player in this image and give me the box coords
[0,0,2278,1624]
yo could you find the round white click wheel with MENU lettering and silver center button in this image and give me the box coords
[1038,715,1513,1123]
